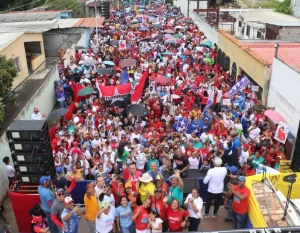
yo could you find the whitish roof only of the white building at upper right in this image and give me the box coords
[232,9,300,23]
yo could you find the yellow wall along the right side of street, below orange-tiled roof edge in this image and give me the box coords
[218,31,270,104]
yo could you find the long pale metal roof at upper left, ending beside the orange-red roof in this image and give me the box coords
[0,19,80,33]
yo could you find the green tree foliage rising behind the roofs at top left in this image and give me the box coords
[45,0,83,17]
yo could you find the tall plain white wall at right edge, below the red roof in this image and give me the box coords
[268,58,300,136]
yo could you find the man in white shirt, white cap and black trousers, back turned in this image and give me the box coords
[203,157,227,218]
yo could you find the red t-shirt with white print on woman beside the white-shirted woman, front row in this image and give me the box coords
[167,206,189,232]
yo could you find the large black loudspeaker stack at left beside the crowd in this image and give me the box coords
[6,120,55,183]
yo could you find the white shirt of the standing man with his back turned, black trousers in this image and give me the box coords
[203,167,227,194]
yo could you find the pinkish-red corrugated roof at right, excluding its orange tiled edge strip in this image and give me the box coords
[247,43,300,71]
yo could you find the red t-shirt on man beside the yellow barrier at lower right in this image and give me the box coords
[232,185,250,214]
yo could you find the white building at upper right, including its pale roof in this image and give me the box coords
[232,9,300,40]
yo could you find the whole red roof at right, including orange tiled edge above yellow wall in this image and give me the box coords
[218,29,300,71]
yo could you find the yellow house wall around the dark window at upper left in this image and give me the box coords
[0,34,45,89]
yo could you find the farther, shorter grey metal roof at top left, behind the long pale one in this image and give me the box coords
[0,11,60,23]
